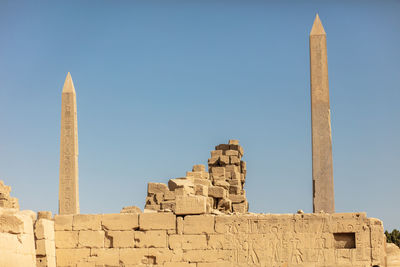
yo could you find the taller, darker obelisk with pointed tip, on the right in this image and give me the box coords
[310,14,335,213]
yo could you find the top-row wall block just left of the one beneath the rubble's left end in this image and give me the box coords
[101,213,139,231]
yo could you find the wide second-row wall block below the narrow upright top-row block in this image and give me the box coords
[168,235,207,250]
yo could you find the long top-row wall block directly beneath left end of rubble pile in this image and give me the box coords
[139,212,176,230]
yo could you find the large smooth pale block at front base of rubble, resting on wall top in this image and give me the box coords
[175,196,207,215]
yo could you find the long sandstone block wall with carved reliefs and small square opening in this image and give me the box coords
[55,212,385,267]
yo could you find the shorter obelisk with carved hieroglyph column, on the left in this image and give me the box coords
[58,72,79,214]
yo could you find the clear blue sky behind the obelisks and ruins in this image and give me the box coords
[0,0,400,230]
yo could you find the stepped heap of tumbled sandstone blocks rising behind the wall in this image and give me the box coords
[145,140,248,215]
